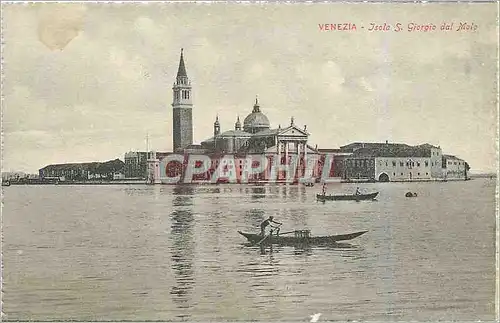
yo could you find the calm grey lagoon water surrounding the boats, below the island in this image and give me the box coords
[3,179,496,321]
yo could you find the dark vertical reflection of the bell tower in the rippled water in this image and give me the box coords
[170,191,195,319]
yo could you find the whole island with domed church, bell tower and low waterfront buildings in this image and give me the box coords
[5,50,470,184]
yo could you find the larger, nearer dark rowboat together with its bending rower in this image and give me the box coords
[238,216,368,246]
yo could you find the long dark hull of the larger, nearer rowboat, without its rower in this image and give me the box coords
[238,231,368,246]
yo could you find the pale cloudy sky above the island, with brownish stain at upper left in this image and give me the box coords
[2,3,498,172]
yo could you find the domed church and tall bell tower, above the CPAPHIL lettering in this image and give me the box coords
[172,50,318,161]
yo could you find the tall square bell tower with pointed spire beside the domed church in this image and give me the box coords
[172,49,193,152]
